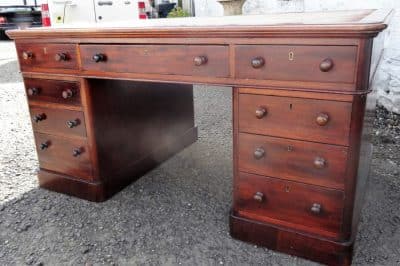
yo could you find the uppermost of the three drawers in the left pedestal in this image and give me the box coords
[24,78,81,106]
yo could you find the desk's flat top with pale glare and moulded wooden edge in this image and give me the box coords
[7,9,392,39]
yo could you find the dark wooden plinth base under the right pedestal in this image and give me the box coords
[229,213,354,265]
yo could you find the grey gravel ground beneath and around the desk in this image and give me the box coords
[0,42,400,265]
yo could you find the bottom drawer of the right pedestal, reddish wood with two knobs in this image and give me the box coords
[234,173,344,238]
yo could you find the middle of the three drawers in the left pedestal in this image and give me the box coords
[30,106,86,137]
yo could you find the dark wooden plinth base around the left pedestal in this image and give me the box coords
[38,127,197,202]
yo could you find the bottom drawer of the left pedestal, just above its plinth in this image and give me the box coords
[35,133,92,179]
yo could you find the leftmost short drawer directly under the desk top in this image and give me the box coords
[16,43,78,70]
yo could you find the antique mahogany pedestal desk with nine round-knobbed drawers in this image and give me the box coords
[8,10,391,265]
